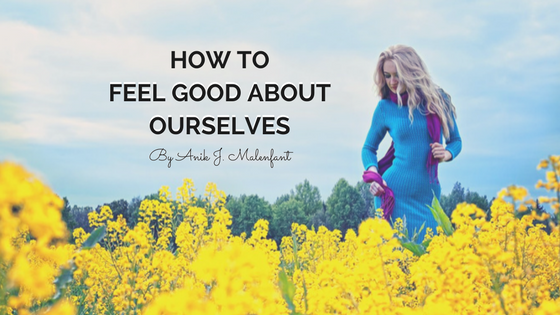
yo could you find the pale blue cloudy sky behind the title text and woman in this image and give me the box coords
[0,0,560,207]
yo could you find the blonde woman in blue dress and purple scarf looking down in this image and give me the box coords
[362,45,462,242]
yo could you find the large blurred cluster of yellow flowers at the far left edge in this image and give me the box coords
[0,162,74,314]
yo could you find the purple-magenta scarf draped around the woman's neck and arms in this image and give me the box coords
[362,91,441,221]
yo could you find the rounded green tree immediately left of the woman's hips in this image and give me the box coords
[327,178,367,235]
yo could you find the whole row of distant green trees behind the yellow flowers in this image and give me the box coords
[62,178,556,243]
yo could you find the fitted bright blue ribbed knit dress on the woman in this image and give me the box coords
[362,99,462,242]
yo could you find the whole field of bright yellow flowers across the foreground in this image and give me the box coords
[0,156,560,315]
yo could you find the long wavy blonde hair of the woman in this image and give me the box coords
[373,45,457,139]
